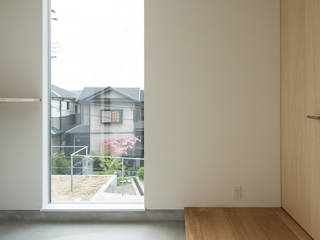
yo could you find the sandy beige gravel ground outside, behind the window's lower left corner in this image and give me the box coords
[51,175,111,202]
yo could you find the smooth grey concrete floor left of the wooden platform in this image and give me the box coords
[0,221,185,240]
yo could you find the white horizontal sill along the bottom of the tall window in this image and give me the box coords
[41,203,145,212]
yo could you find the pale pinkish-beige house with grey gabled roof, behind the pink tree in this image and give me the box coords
[58,87,144,157]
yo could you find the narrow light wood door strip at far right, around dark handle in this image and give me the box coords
[305,0,320,239]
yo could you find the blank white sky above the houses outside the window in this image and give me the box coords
[51,0,144,90]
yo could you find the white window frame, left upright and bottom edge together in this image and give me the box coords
[40,0,146,210]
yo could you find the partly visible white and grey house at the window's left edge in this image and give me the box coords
[51,85,80,153]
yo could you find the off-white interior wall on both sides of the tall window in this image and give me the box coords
[0,0,280,209]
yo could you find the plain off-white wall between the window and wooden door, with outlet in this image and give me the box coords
[145,0,280,209]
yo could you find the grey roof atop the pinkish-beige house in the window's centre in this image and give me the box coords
[77,87,143,101]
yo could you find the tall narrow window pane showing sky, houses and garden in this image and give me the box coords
[49,0,144,203]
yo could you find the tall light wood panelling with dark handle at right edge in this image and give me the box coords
[281,0,320,239]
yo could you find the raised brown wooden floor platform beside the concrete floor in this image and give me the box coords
[185,208,311,240]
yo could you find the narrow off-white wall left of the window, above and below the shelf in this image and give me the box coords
[0,0,42,209]
